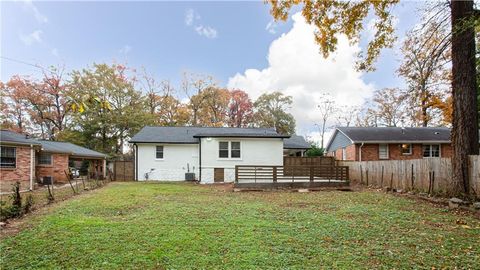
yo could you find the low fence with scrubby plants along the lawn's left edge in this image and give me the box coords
[0,177,110,225]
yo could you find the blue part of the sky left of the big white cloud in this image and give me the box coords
[1,2,288,83]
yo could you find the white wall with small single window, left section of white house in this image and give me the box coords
[138,144,199,181]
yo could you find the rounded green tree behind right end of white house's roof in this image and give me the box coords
[254,92,295,135]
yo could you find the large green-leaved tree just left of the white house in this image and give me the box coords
[71,64,148,156]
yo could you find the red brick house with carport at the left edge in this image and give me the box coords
[0,130,107,192]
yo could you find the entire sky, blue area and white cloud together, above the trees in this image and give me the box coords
[0,1,421,138]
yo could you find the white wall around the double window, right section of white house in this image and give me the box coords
[201,138,283,183]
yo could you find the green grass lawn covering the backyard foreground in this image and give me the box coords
[0,182,480,269]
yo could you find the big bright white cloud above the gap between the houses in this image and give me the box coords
[228,13,373,142]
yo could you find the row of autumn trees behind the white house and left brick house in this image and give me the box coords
[0,64,294,156]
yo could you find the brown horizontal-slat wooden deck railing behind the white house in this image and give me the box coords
[235,165,349,183]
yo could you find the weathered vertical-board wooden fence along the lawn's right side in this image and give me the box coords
[338,156,480,197]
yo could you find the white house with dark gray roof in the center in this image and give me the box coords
[130,126,310,183]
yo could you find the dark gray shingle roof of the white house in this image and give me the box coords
[130,126,289,144]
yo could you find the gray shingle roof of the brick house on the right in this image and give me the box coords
[337,127,450,143]
